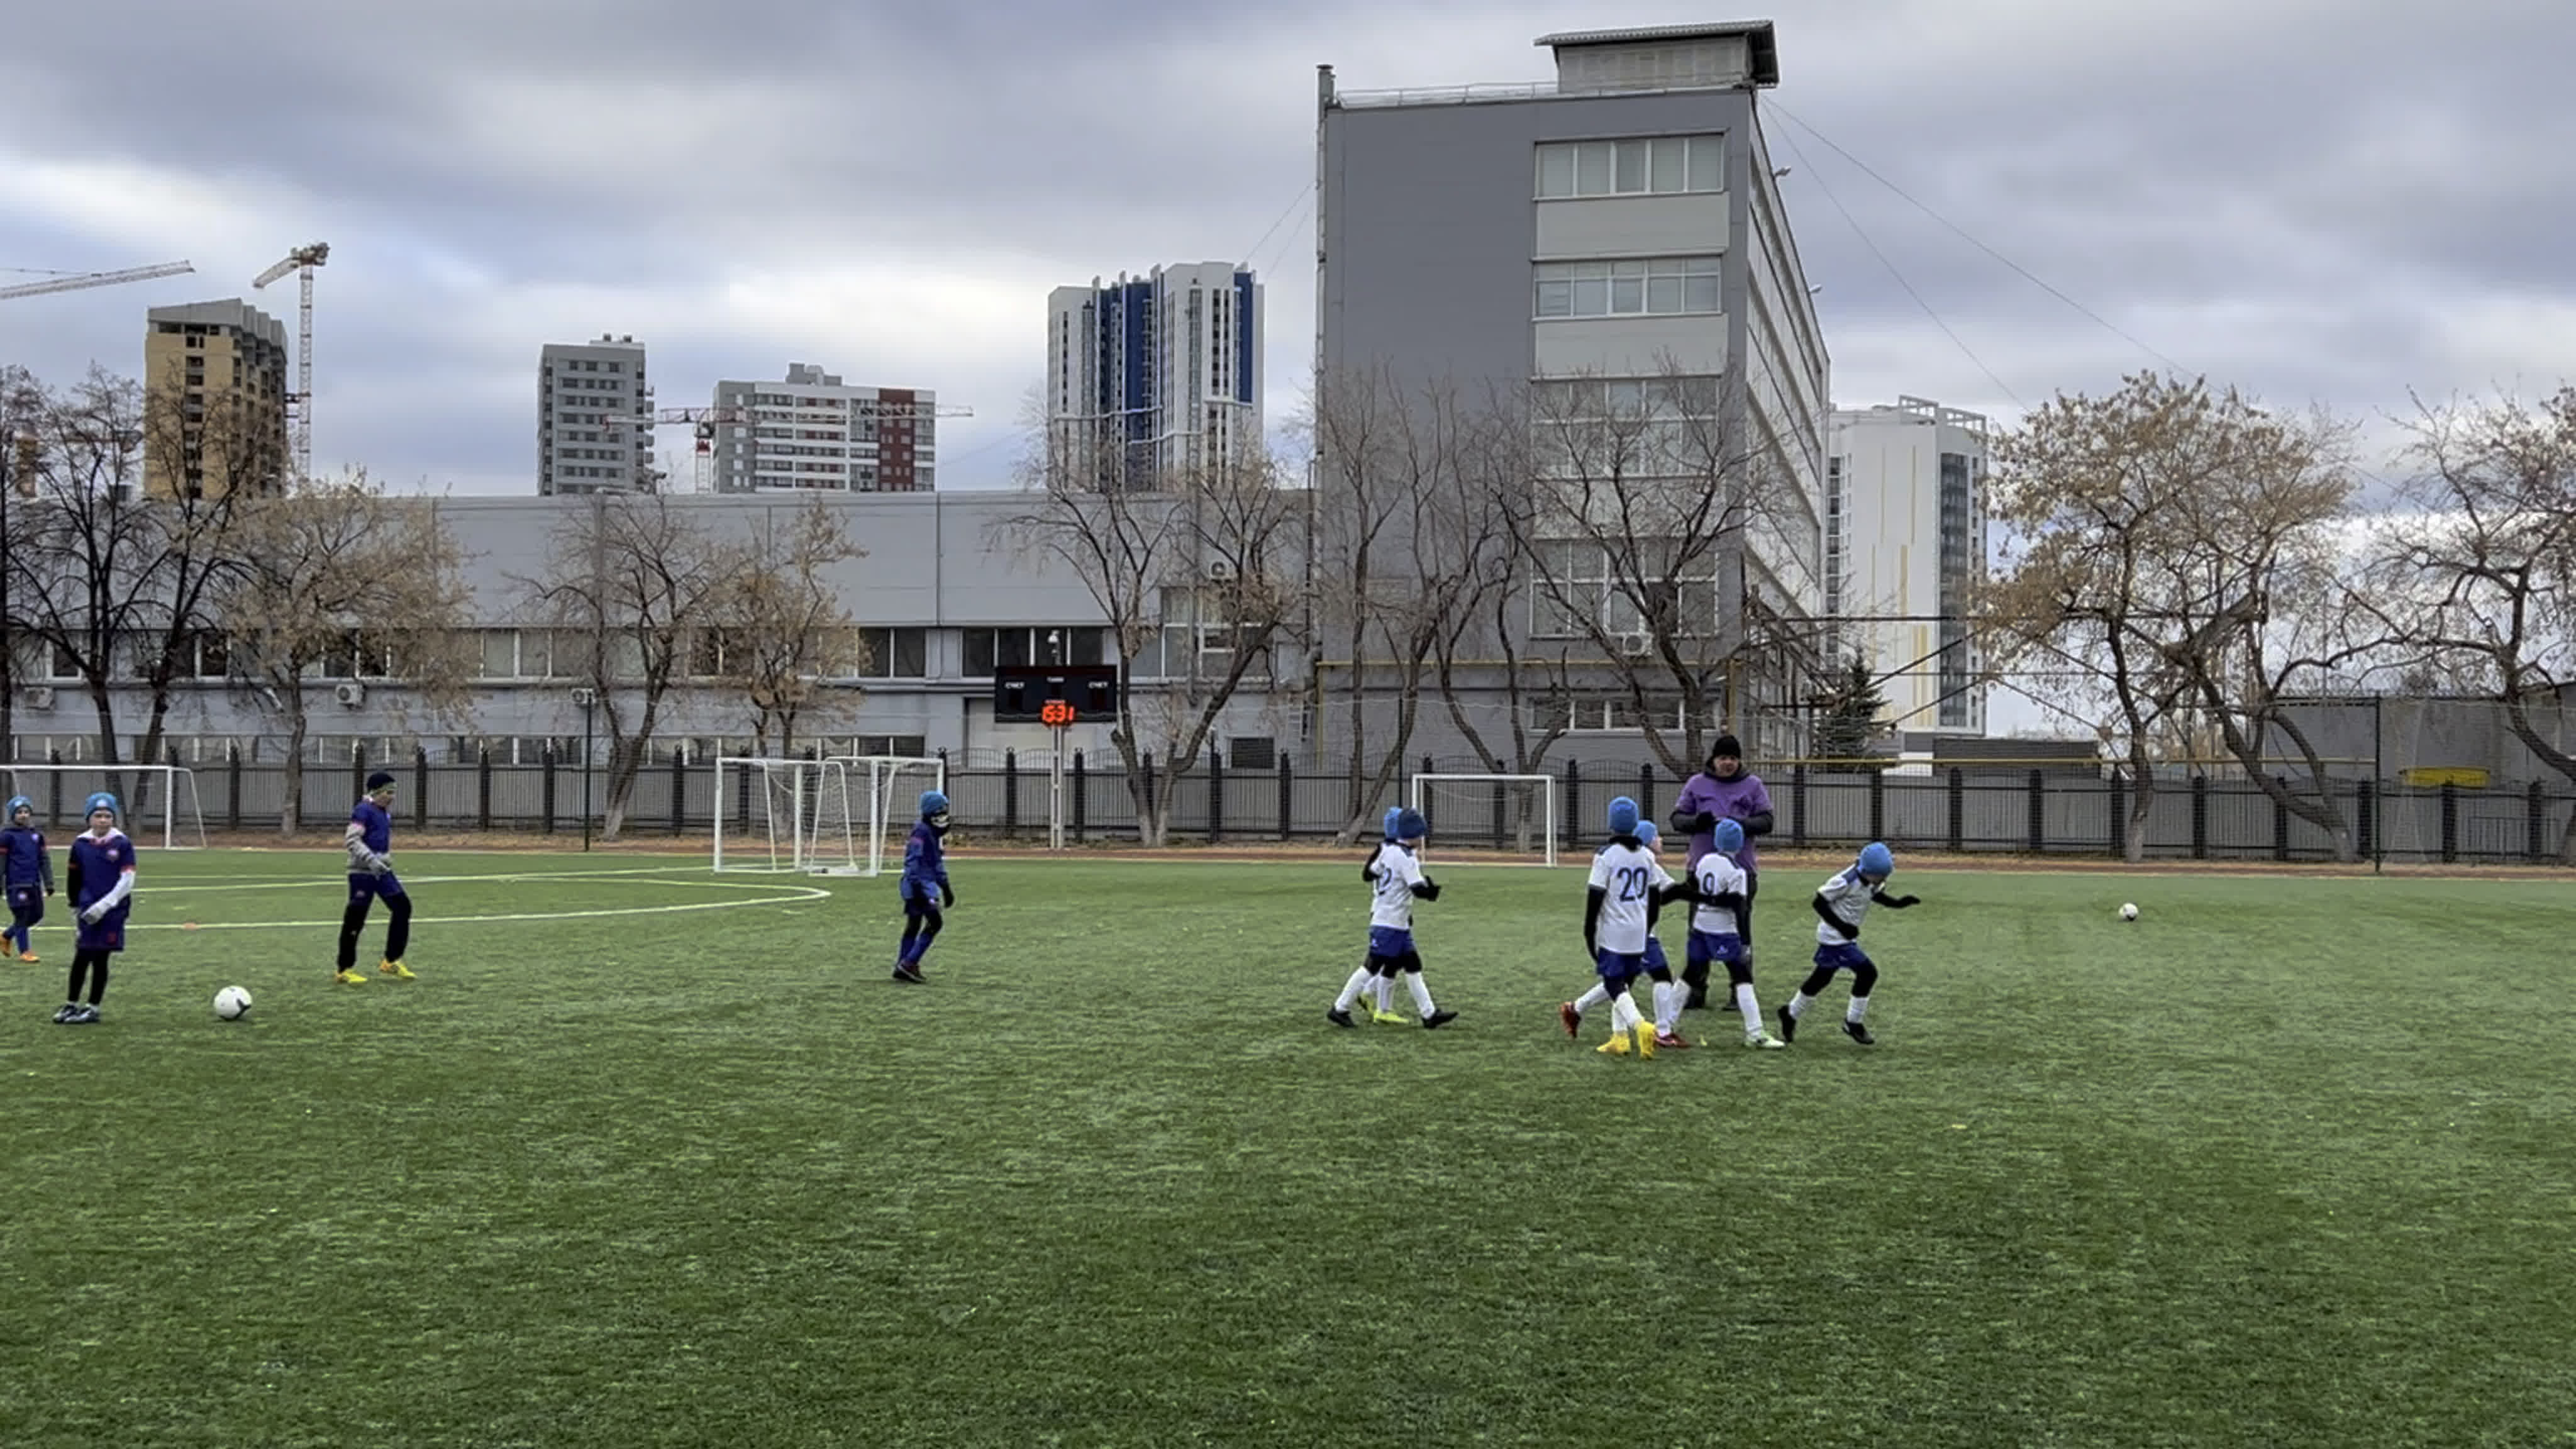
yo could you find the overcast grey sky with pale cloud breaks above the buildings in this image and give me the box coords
[0,0,2576,492]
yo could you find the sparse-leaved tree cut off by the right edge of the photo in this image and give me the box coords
[2362,387,2576,863]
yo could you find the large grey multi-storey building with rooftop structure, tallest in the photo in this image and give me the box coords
[1316,21,1829,750]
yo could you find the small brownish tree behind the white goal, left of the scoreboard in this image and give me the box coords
[701,497,868,755]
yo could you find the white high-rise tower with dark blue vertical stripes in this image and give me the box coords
[1046,260,1262,490]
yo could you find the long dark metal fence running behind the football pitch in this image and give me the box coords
[36,737,2576,863]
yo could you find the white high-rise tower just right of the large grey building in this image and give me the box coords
[1824,397,1989,735]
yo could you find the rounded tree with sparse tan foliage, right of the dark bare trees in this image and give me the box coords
[216,469,472,835]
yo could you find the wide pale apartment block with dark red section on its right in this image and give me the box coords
[711,364,940,492]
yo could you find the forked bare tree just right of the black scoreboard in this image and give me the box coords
[994,431,1306,846]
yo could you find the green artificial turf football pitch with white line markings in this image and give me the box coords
[0,853,2576,1449]
